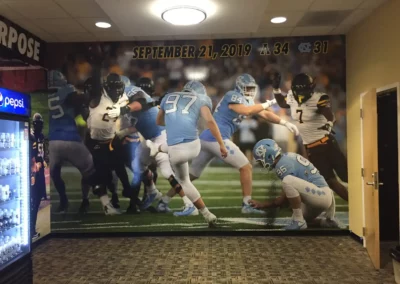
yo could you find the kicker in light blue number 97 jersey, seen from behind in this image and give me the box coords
[147,81,227,226]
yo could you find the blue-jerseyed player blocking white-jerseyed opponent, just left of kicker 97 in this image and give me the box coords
[108,77,199,215]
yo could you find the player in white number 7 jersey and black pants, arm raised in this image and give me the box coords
[271,73,348,201]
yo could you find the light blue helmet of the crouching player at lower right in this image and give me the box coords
[253,139,282,170]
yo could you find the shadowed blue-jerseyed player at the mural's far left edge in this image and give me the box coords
[48,70,117,215]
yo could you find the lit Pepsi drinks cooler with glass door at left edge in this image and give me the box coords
[0,88,31,271]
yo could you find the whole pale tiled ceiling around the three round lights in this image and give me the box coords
[0,0,387,42]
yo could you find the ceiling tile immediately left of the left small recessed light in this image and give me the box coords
[35,19,86,34]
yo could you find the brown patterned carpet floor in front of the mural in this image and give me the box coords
[33,236,395,284]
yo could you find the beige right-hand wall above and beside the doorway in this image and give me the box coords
[346,0,400,236]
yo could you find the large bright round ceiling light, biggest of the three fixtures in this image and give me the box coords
[161,6,207,26]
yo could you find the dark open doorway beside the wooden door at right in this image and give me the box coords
[377,89,399,244]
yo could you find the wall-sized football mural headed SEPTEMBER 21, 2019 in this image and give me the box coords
[40,36,348,233]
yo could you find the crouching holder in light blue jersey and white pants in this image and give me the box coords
[249,139,338,230]
